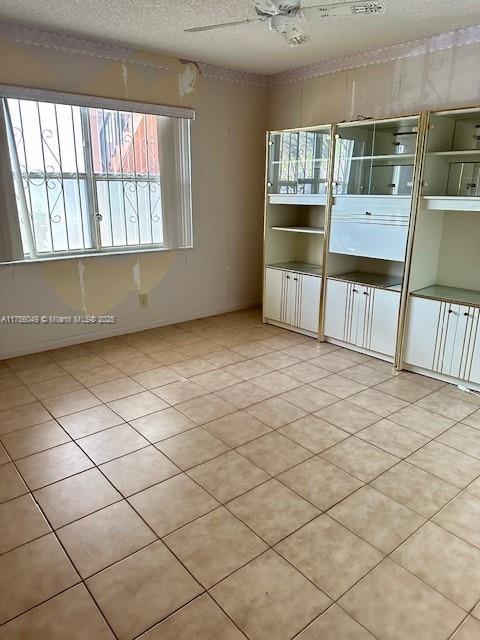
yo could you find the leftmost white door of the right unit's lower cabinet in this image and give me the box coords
[404,296,441,371]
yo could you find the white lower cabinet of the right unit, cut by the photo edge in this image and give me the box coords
[404,296,480,383]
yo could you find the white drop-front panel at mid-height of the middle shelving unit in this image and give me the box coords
[329,196,410,262]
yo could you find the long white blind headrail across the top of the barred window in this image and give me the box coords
[0,84,195,120]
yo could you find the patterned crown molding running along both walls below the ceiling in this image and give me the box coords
[0,22,480,87]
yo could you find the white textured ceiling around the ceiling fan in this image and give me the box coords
[0,0,480,74]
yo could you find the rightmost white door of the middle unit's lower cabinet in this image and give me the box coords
[365,288,400,356]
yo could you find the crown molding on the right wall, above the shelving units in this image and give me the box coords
[268,24,480,86]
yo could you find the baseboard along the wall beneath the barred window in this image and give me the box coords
[0,300,261,360]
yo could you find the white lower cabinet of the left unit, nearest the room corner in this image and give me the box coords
[264,267,322,334]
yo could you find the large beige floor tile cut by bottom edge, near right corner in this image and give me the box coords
[340,559,465,640]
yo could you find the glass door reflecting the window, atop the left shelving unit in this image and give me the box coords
[268,130,330,195]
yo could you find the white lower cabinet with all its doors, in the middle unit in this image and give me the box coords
[324,278,400,357]
